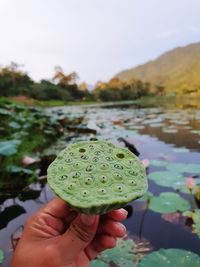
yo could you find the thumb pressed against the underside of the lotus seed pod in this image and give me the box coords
[61,214,99,260]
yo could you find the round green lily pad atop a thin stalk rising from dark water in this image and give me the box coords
[149,192,190,213]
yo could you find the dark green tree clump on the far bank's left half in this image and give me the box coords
[0,63,90,101]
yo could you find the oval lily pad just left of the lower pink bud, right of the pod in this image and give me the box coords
[148,171,185,190]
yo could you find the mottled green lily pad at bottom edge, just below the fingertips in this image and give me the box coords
[90,239,137,267]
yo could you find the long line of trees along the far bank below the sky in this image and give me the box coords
[0,62,155,102]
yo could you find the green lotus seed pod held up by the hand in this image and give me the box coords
[47,141,147,214]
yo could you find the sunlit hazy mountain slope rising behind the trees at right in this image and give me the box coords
[115,42,200,92]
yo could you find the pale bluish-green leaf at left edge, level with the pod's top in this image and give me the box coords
[0,139,21,156]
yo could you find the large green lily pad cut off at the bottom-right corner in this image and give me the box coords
[139,248,200,267]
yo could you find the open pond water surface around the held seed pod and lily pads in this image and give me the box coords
[0,105,200,266]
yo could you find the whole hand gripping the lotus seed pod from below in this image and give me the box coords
[11,198,127,267]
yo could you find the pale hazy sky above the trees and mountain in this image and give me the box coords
[0,0,200,84]
